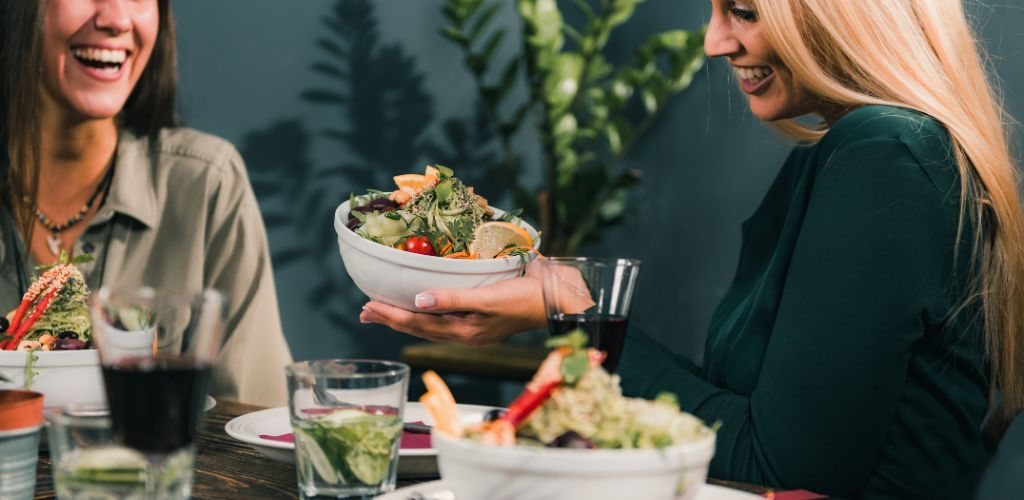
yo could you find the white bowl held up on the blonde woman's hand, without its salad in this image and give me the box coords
[334,201,540,311]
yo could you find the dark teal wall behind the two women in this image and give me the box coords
[174,0,1024,403]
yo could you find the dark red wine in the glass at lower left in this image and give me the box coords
[103,356,210,453]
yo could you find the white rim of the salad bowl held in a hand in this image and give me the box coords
[334,200,541,275]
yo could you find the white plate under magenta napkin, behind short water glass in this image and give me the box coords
[224,402,495,477]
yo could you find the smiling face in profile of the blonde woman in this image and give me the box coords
[705,0,819,122]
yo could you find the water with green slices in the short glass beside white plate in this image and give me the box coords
[292,409,401,498]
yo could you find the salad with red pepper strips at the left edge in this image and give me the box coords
[0,254,92,351]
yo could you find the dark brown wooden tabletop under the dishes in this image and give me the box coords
[36,401,767,500]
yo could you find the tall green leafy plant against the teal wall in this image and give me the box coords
[441,0,703,255]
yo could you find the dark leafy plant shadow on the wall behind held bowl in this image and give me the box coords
[242,0,502,357]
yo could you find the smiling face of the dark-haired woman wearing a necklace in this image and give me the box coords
[43,0,160,120]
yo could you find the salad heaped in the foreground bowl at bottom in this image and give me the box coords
[420,330,715,449]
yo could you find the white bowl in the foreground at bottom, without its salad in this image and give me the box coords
[433,431,715,500]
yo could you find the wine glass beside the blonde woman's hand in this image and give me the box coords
[541,257,640,372]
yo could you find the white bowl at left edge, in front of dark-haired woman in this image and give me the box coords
[0,349,106,408]
